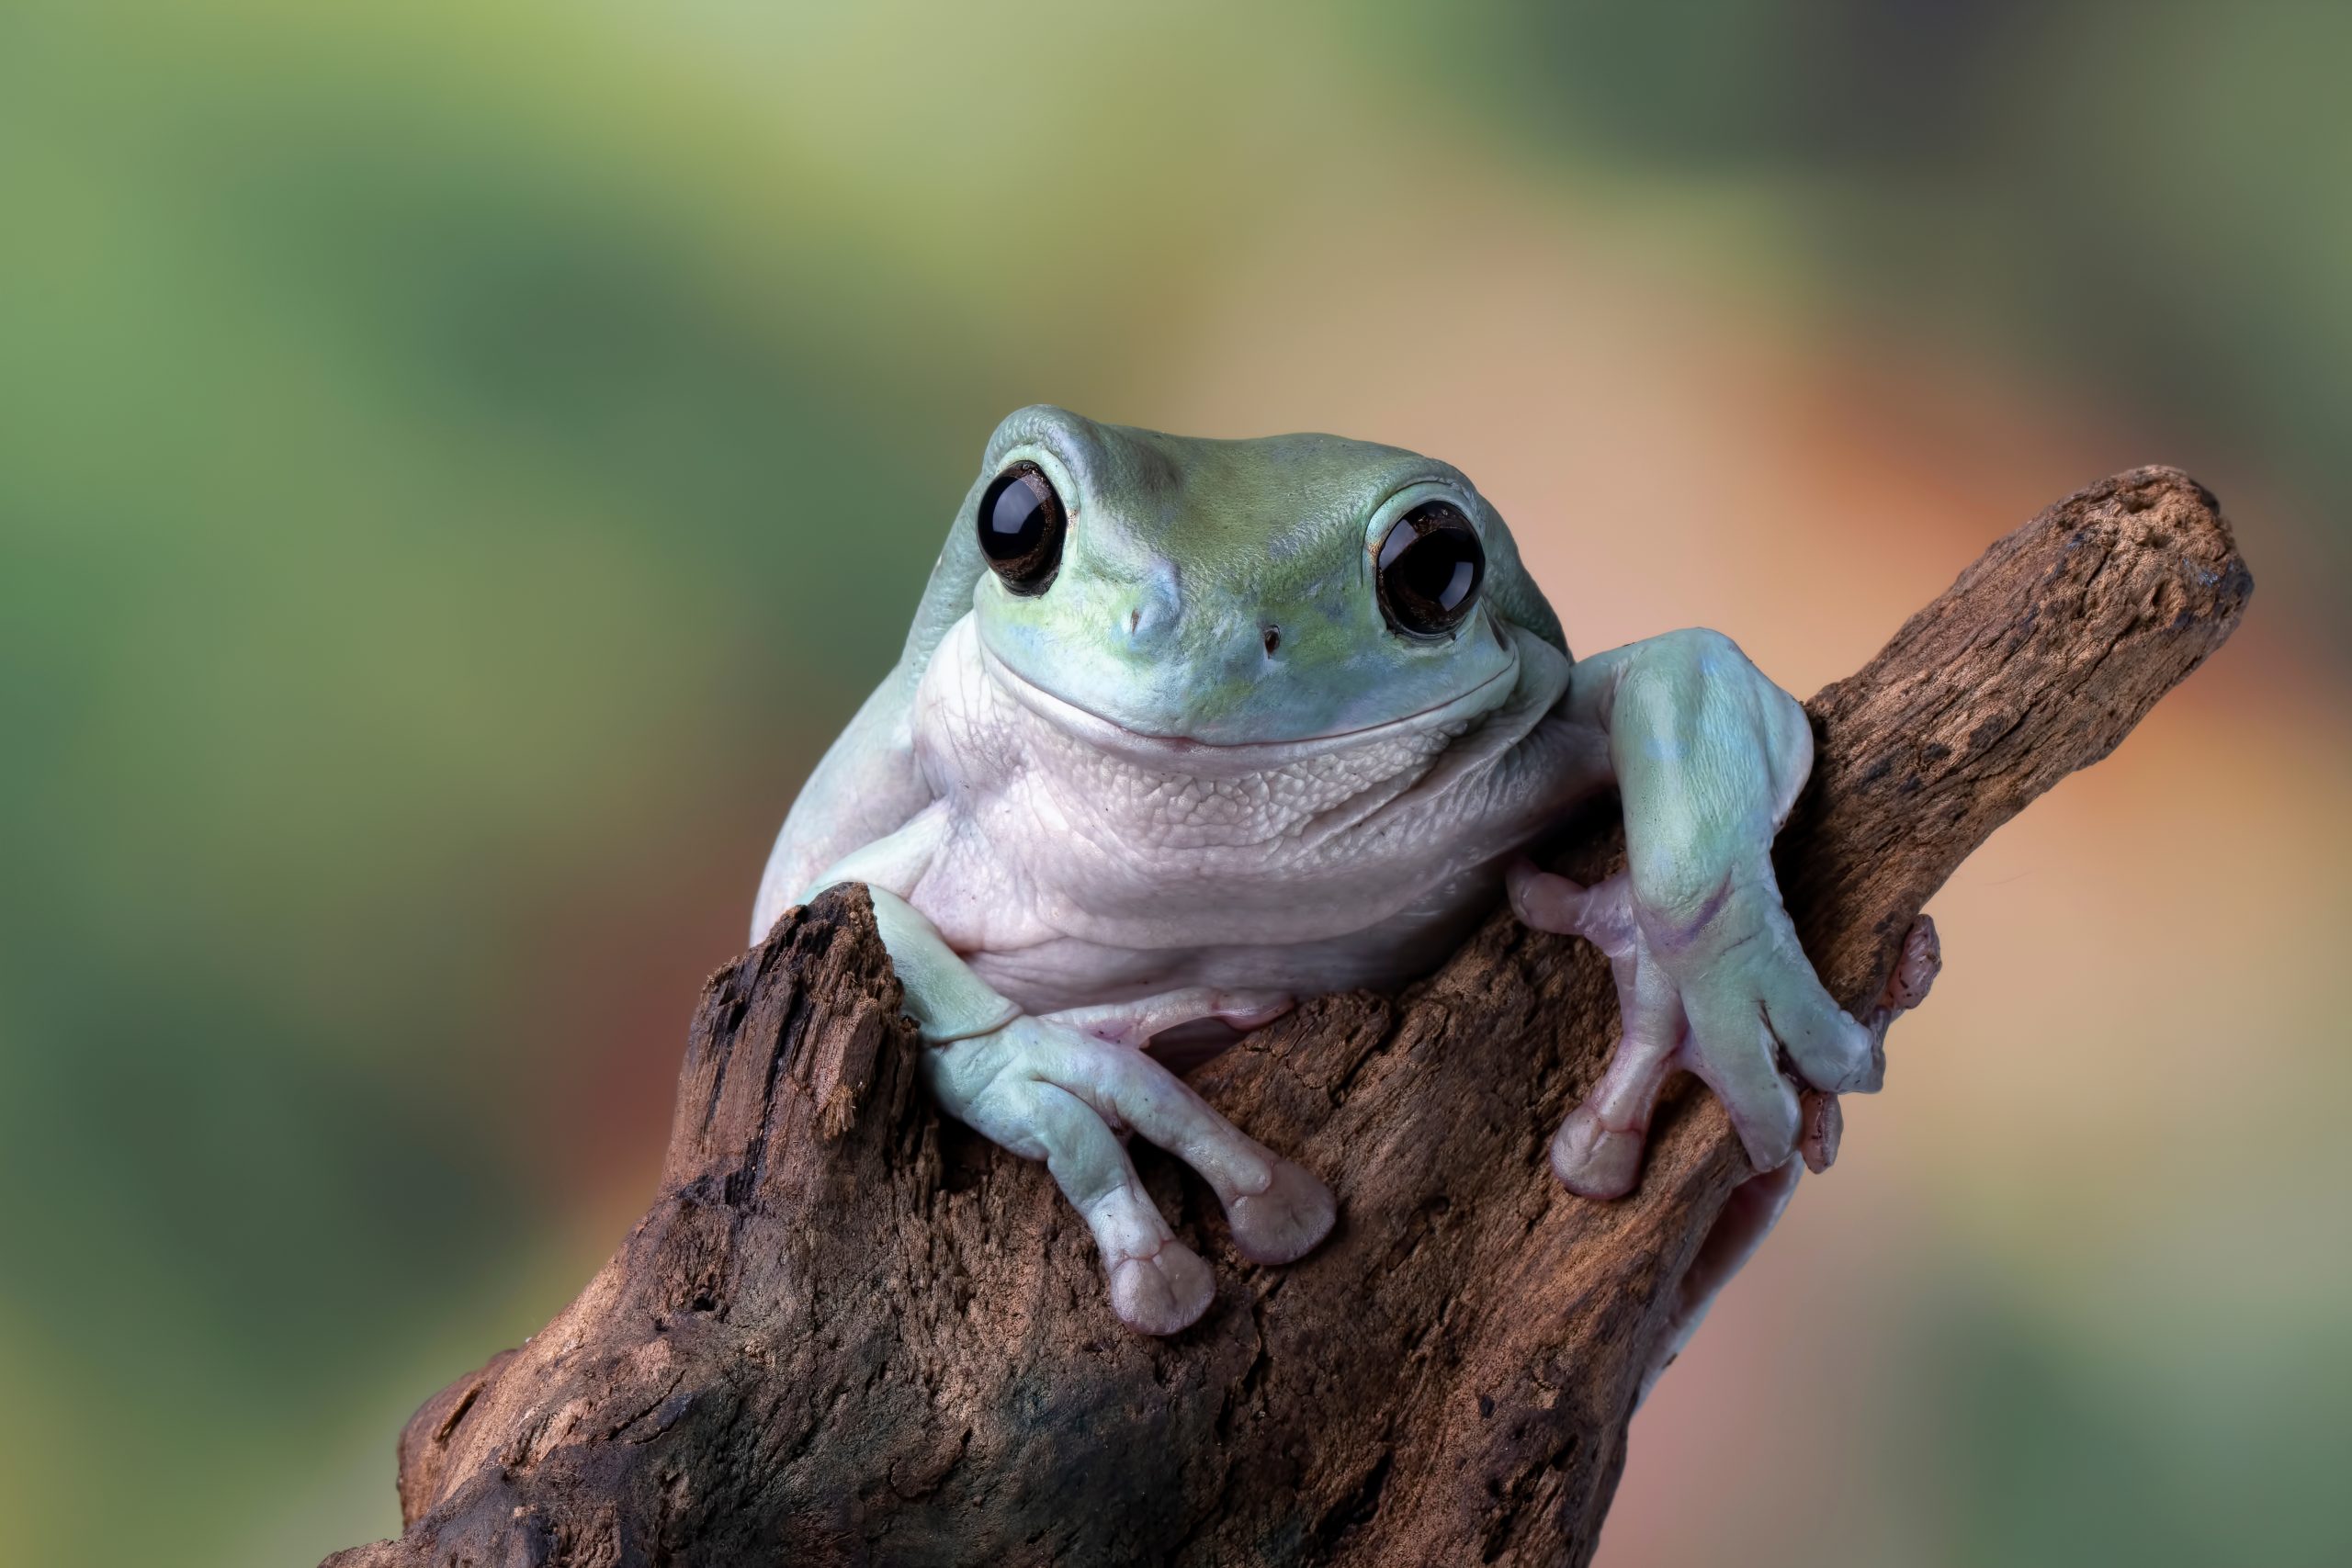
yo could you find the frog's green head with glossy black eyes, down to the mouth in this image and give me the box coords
[950,407,1559,766]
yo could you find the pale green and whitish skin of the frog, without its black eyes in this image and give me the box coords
[752,407,1879,1333]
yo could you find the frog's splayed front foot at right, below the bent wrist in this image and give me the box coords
[1510,861,1879,1199]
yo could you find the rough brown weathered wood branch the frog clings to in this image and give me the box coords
[329,468,2253,1568]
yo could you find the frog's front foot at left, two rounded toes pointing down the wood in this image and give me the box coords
[924,1009,1336,1333]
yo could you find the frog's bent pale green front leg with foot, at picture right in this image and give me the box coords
[1510,632,1882,1199]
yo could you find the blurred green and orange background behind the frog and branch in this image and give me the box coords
[0,0,2352,1568]
